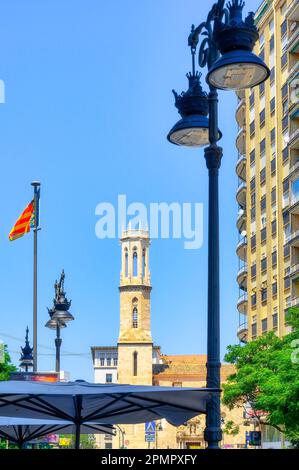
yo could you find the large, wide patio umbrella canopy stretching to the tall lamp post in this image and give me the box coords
[0,380,220,446]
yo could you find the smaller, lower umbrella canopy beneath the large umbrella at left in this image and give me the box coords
[0,416,115,447]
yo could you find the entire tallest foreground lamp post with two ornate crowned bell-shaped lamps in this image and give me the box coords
[167,0,270,449]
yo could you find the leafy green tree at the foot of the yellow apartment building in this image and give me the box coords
[223,308,299,447]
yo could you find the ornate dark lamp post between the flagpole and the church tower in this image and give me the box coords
[45,270,74,372]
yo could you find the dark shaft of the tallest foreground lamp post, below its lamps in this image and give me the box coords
[204,87,222,449]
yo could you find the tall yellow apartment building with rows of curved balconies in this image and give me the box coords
[236,0,299,342]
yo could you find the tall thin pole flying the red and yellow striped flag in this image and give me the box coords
[31,181,40,372]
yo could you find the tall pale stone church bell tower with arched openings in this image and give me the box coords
[117,230,153,385]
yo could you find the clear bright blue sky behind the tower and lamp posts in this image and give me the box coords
[0,0,260,380]
